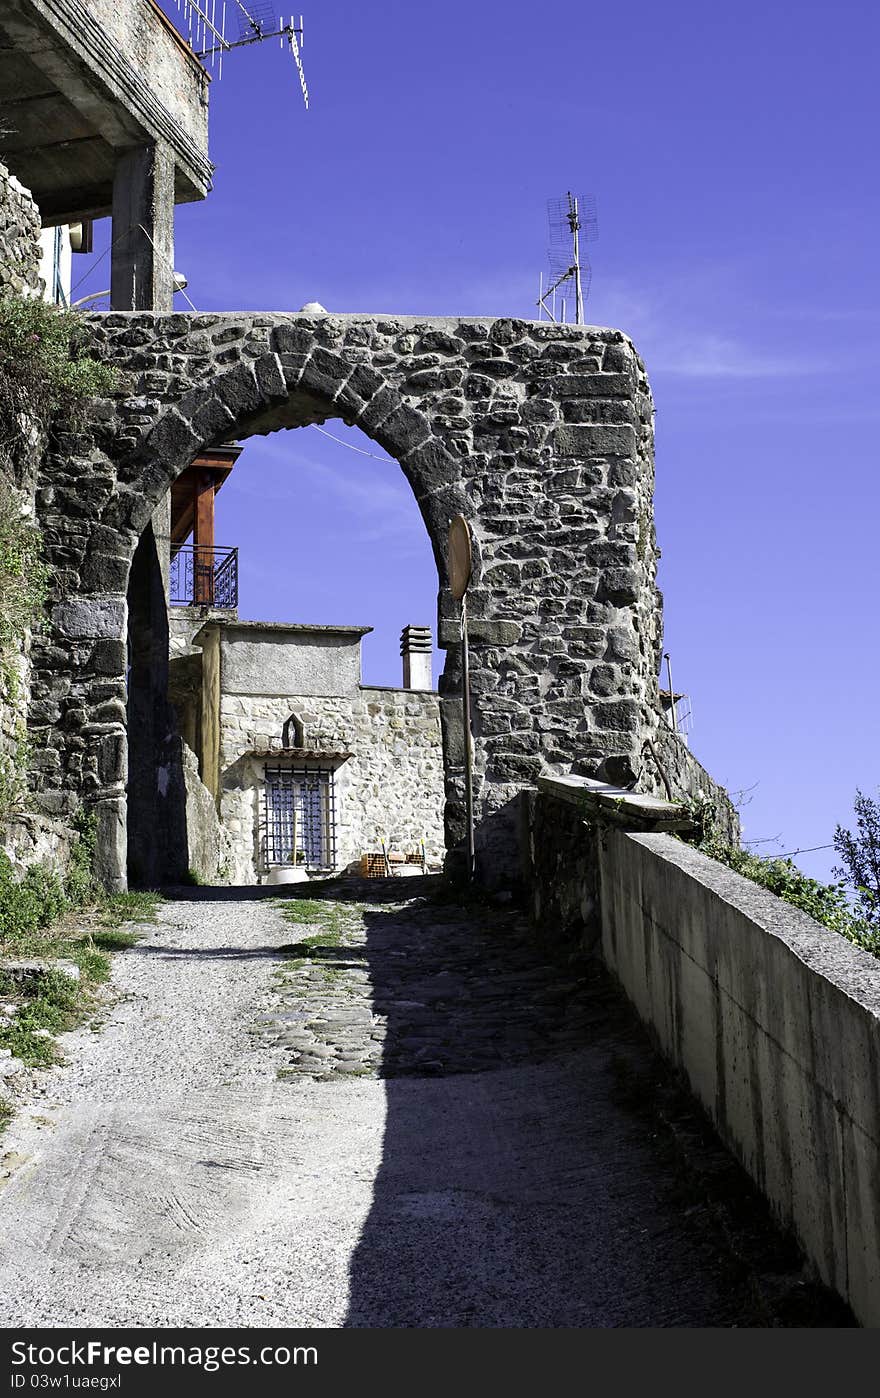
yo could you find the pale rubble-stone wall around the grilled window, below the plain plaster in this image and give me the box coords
[220,686,443,884]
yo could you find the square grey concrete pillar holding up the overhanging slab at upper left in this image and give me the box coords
[111,144,173,312]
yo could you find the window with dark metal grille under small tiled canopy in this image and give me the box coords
[264,768,336,870]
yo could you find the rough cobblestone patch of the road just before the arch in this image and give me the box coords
[263,879,618,1081]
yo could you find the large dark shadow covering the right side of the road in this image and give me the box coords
[260,879,852,1328]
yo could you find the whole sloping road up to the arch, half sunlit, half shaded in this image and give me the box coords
[0,881,845,1327]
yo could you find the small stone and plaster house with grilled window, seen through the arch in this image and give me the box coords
[171,615,443,884]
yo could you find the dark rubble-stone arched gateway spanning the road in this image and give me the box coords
[31,313,659,886]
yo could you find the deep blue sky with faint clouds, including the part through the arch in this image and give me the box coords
[77,0,880,877]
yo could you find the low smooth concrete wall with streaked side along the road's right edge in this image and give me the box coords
[597,829,880,1327]
